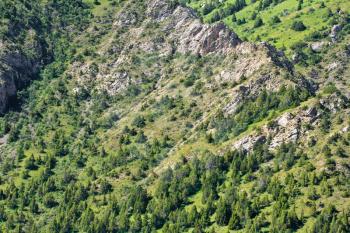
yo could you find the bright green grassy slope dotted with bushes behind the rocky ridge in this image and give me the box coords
[185,0,350,54]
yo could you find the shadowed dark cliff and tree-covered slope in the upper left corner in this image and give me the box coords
[0,0,90,114]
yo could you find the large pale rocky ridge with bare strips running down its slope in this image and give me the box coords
[75,0,316,176]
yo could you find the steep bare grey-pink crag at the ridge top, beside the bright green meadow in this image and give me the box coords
[147,0,241,55]
